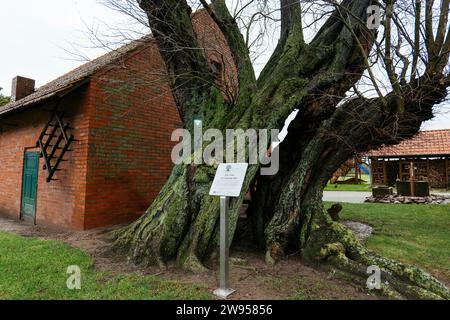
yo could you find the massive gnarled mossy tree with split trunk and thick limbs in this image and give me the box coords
[115,0,450,298]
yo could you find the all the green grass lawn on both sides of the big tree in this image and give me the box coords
[0,203,450,299]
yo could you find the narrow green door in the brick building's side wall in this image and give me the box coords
[21,152,39,220]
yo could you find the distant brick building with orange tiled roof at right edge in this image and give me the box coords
[367,130,450,189]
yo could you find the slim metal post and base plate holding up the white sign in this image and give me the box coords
[214,196,235,299]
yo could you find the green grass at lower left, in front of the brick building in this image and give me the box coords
[0,232,211,300]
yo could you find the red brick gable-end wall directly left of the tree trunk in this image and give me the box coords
[85,44,181,229]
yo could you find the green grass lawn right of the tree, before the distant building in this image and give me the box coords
[326,203,450,282]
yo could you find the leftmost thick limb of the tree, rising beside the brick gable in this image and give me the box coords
[138,0,213,126]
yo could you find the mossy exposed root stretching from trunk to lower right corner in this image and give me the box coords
[303,215,450,299]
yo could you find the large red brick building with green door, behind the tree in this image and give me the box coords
[0,11,236,230]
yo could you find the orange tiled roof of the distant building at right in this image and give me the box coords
[368,129,450,157]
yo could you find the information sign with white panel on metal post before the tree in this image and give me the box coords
[209,163,248,299]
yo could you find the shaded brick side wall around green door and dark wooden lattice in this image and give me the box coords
[0,89,88,229]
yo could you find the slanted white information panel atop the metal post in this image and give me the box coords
[209,163,248,197]
